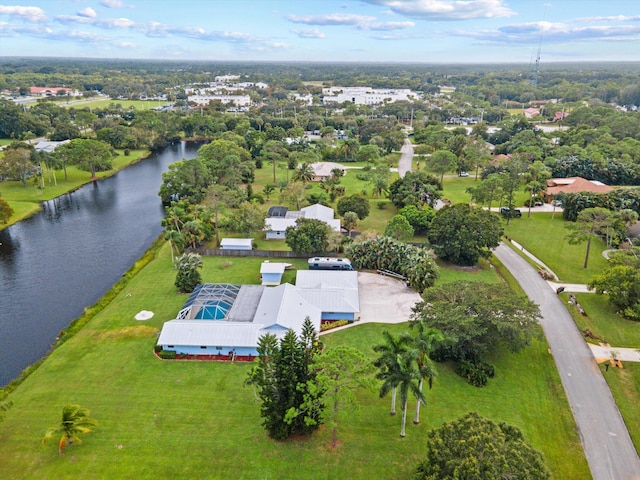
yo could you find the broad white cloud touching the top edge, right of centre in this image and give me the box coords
[364,0,516,20]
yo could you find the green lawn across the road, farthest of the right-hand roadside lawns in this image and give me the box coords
[504,212,607,283]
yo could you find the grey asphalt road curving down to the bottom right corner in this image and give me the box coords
[495,245,640,480]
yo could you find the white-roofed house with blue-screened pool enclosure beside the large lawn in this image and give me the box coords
[157,270,360,360]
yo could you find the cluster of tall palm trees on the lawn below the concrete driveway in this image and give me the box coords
[373,321,444,437]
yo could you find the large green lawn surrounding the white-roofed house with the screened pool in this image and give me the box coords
[0,245,589,479]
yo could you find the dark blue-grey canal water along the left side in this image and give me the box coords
[0,142,201,386]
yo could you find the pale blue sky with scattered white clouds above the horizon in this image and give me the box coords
[0,0,640,63]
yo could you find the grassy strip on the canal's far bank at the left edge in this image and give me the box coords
[0,150,149,226]
